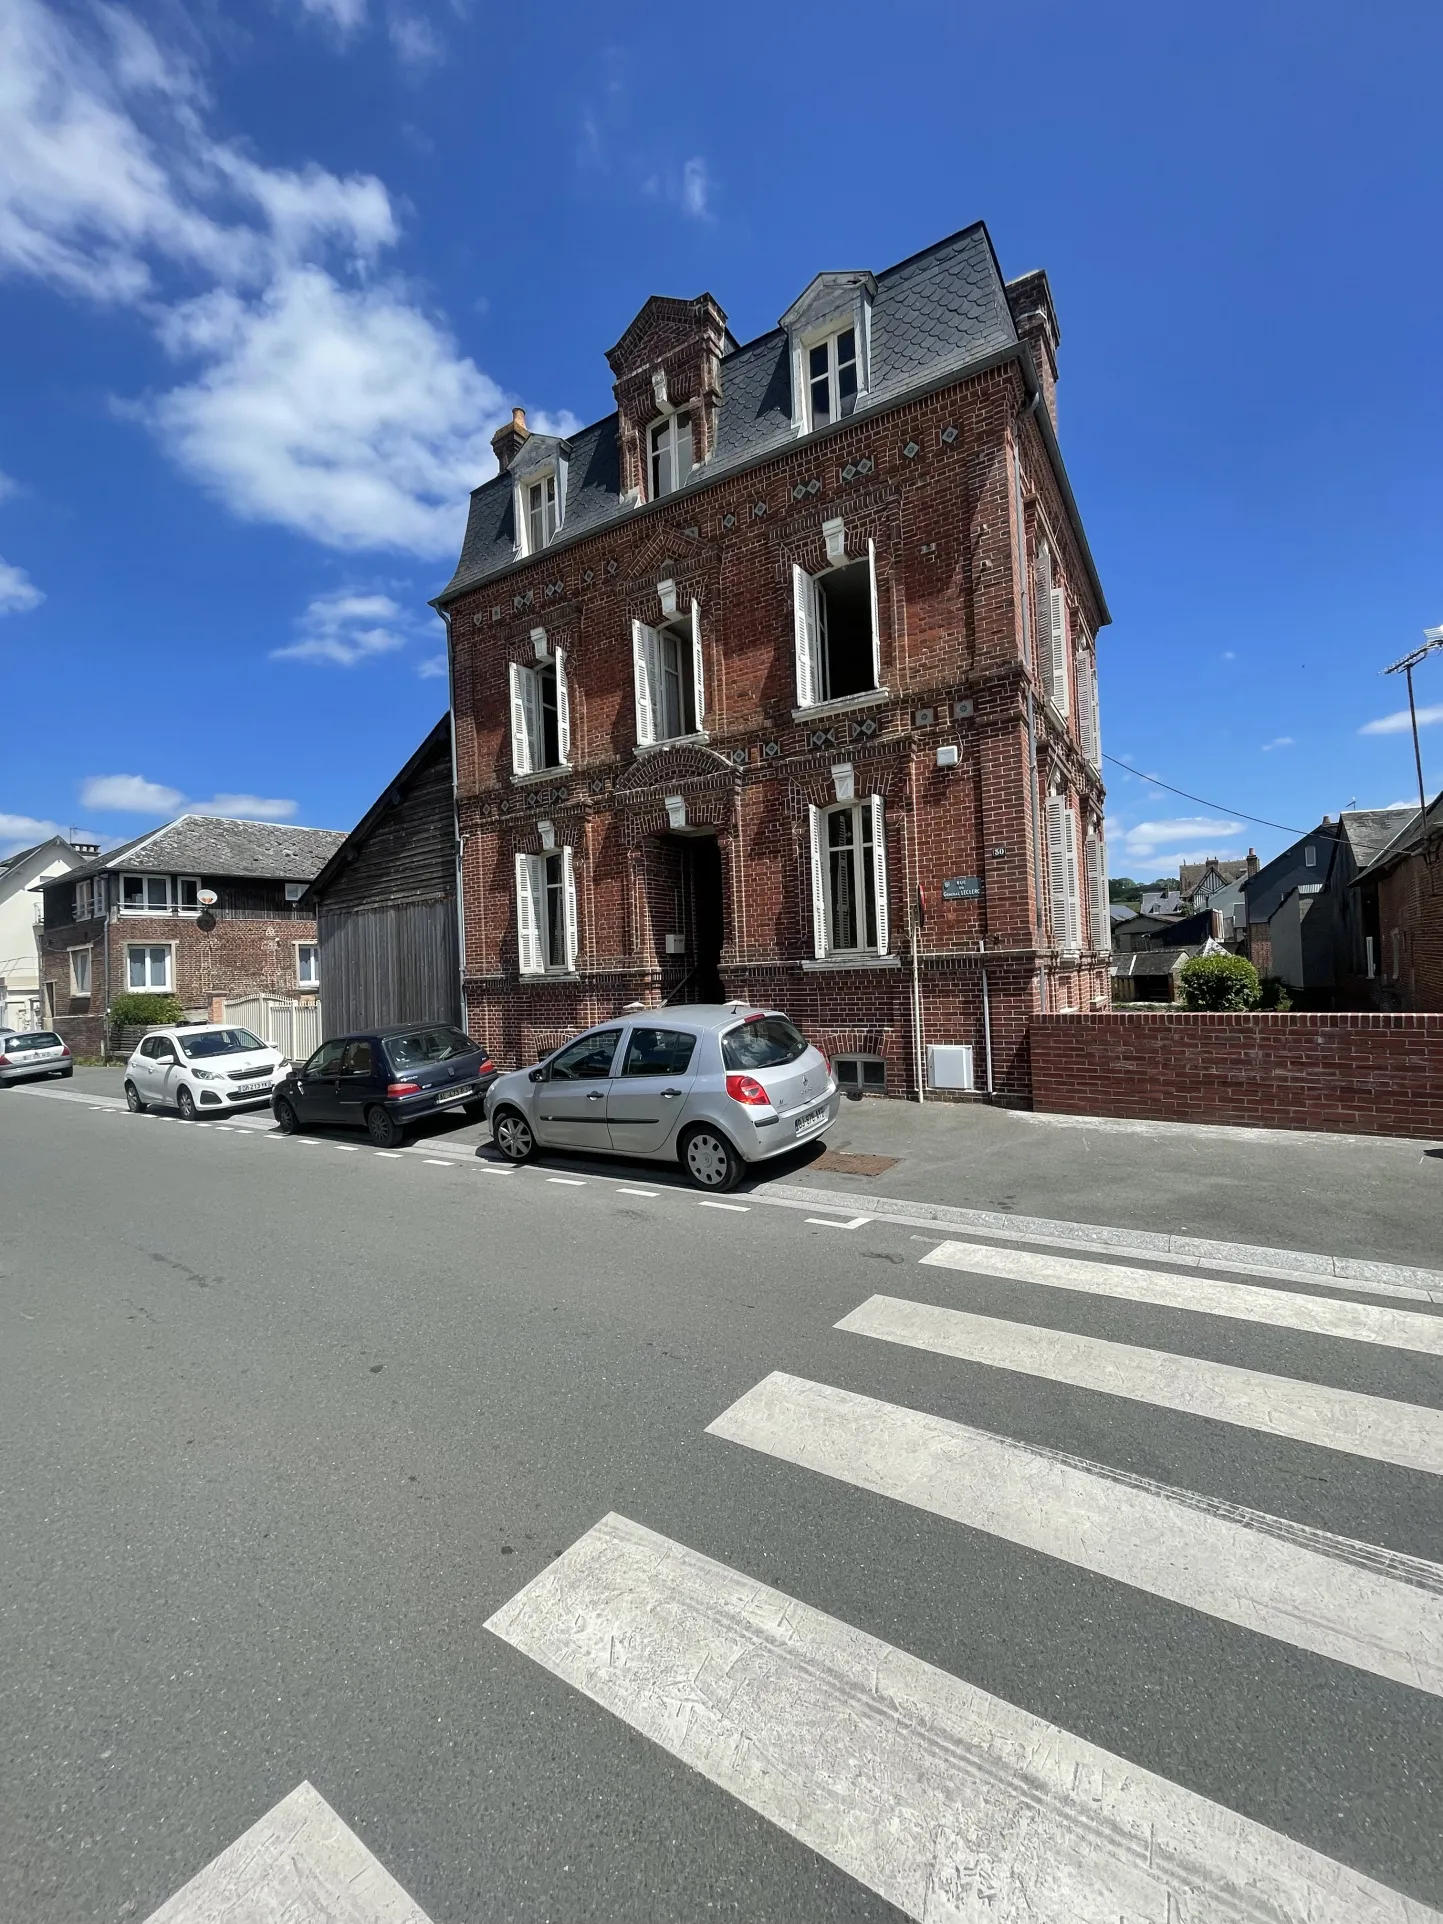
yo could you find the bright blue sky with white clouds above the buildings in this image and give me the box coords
[0,0,1443,877]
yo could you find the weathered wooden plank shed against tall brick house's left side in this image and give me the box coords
[300,714,462,1035]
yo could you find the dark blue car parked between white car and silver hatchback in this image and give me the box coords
[271,1022,496,1149]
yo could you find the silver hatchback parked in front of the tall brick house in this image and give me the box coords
[487,1002,841,1191]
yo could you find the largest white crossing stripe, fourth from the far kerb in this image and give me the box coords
[487,1516,1443,1924]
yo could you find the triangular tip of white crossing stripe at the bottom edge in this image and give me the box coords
[146,1784,429,1924]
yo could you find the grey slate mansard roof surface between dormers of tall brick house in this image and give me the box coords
[437,221,1062,604]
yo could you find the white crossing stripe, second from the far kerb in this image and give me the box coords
[837,1297,1443,1476]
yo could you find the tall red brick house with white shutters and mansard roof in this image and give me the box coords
[437,225,1110,1097]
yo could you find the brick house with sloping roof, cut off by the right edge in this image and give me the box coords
[1353,793,1443,1012]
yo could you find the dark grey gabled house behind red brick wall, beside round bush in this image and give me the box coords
[1243,808,1418,1008]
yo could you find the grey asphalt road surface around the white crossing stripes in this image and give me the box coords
[0,1085,1443,1924]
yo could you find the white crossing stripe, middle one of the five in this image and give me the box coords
[708,1372,1443,1697]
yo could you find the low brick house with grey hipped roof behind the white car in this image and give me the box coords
[38,816,344,1054]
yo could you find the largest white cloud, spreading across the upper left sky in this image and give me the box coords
[0,0,557,558]
